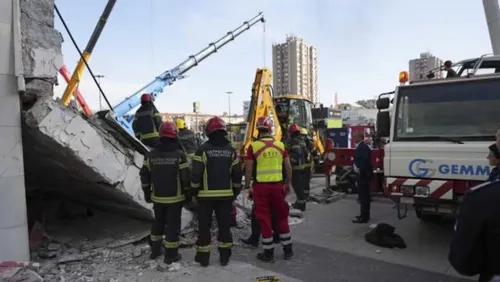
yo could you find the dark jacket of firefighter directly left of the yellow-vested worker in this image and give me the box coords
[191,137,243,199]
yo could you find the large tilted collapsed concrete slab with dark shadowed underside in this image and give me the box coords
[23,97,151,219]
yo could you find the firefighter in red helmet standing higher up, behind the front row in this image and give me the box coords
[132,93,162,148]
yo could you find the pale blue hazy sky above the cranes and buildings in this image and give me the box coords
[56,0,491,114]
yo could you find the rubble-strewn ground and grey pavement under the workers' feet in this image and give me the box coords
[0,178,469,282]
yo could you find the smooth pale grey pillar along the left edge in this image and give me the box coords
[0,0,30,261]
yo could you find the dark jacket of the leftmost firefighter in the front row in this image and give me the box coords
[140,140,190,204]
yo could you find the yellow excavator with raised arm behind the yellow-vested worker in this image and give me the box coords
[240,68,324,166]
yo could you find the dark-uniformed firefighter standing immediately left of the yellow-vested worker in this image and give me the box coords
[191,117,242,267]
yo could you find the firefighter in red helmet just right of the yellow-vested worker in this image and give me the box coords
[288,123,310,211]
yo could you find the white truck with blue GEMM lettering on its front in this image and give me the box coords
[377,56,500,219]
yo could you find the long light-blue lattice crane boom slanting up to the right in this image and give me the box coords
[113,12,265,135]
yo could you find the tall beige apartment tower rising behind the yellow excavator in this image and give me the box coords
[273,36,318,103]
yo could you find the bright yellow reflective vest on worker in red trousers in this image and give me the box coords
[252,137,285,183]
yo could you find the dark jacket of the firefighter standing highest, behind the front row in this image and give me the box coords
[132,104,162,141]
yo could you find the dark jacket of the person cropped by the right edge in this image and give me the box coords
[448,180,500,282]
